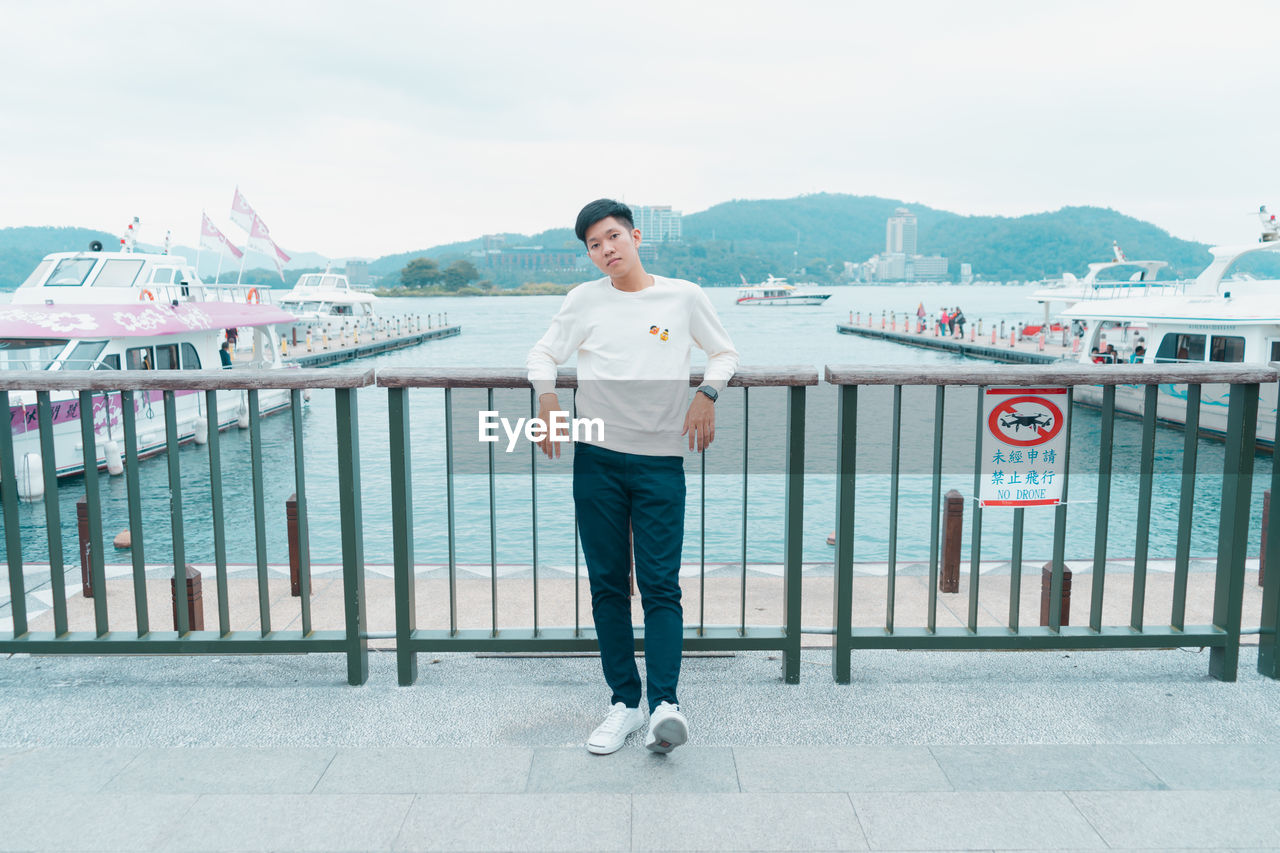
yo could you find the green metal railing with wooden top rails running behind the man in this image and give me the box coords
[0,365,1280,684]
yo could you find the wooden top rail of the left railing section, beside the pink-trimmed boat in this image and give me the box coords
[0,368,374,391]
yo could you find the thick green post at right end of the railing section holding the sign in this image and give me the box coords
[1208,384,1258,681]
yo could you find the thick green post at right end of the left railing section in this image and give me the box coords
[334,388,369,685]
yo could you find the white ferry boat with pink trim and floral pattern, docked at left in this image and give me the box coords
[0,241,292,498]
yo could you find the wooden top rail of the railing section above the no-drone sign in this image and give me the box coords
[826,361,1280,386]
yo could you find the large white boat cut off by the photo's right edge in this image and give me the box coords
[1062,212,1280,446]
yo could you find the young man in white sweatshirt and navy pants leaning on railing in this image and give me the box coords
[527,199,737,754]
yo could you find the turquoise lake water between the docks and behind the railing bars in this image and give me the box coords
[5,286,1271,571]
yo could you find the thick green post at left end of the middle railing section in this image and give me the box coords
[387,388,417,686]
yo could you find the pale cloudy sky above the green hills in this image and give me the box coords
[0,0,1280,257]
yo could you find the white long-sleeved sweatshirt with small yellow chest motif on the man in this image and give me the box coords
[525,275,737,456]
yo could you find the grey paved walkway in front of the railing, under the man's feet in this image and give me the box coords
[0,649,1280,850]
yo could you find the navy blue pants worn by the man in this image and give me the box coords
[573,443,685,712]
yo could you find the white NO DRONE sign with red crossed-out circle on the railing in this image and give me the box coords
[978,388,1070,507]
